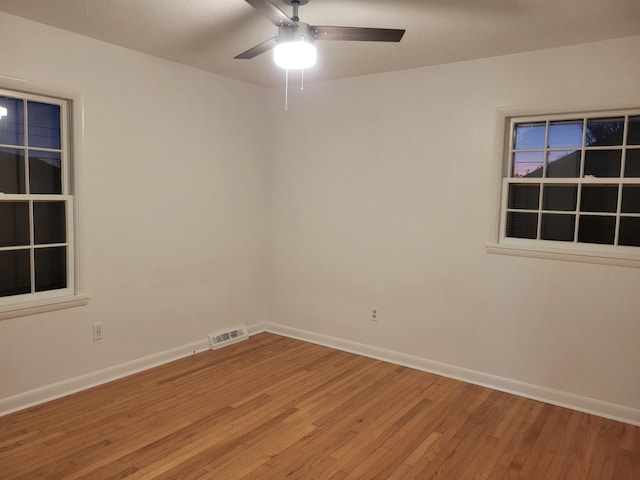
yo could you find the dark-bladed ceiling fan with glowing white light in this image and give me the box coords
[234,0,405,70]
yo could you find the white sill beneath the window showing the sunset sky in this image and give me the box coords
[486,242,640,268]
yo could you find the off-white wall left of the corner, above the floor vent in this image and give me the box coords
[0,14,269,399]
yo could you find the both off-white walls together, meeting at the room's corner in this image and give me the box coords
[0,9,640,422]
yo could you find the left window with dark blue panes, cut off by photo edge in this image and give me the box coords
[0,85,85,318]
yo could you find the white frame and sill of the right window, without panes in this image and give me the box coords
[486,98,640,268]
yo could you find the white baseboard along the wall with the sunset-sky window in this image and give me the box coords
[249,323,640,426]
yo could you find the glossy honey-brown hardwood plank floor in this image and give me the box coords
[0,334,640,480]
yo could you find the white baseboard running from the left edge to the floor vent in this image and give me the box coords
[0,338,210,416]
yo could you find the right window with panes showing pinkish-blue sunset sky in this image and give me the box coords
[493,110,640,266]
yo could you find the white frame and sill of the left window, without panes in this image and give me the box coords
[0,76,89,320]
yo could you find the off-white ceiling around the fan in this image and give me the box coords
[0,0,640,86]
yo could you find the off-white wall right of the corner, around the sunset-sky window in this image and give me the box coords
[269,37,640,412]
